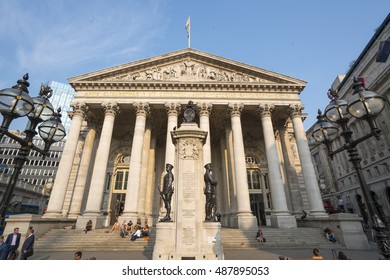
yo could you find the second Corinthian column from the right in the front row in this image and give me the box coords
[258,104,297,228]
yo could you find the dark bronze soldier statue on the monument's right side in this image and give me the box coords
[204,163,218,222]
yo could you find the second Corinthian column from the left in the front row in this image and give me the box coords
[77,102,119,228]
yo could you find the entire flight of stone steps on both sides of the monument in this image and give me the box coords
[34,227,342,252]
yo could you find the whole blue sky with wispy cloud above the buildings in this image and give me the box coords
[0,0,390,129]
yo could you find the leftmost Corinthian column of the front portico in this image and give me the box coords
[44,102,88,218]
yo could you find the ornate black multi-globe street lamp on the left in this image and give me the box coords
[0,74,65,230]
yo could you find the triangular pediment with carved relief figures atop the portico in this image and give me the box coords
[69,49,306,87]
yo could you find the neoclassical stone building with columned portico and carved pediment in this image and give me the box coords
[44,48,326,229]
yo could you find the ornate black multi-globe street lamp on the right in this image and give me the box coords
[313,78,390,260]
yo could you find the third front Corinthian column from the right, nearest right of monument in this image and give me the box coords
[228,103,257,230]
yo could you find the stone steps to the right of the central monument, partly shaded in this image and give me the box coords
[222,227,343,249]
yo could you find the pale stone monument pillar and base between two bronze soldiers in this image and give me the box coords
[153,123,224,260]
